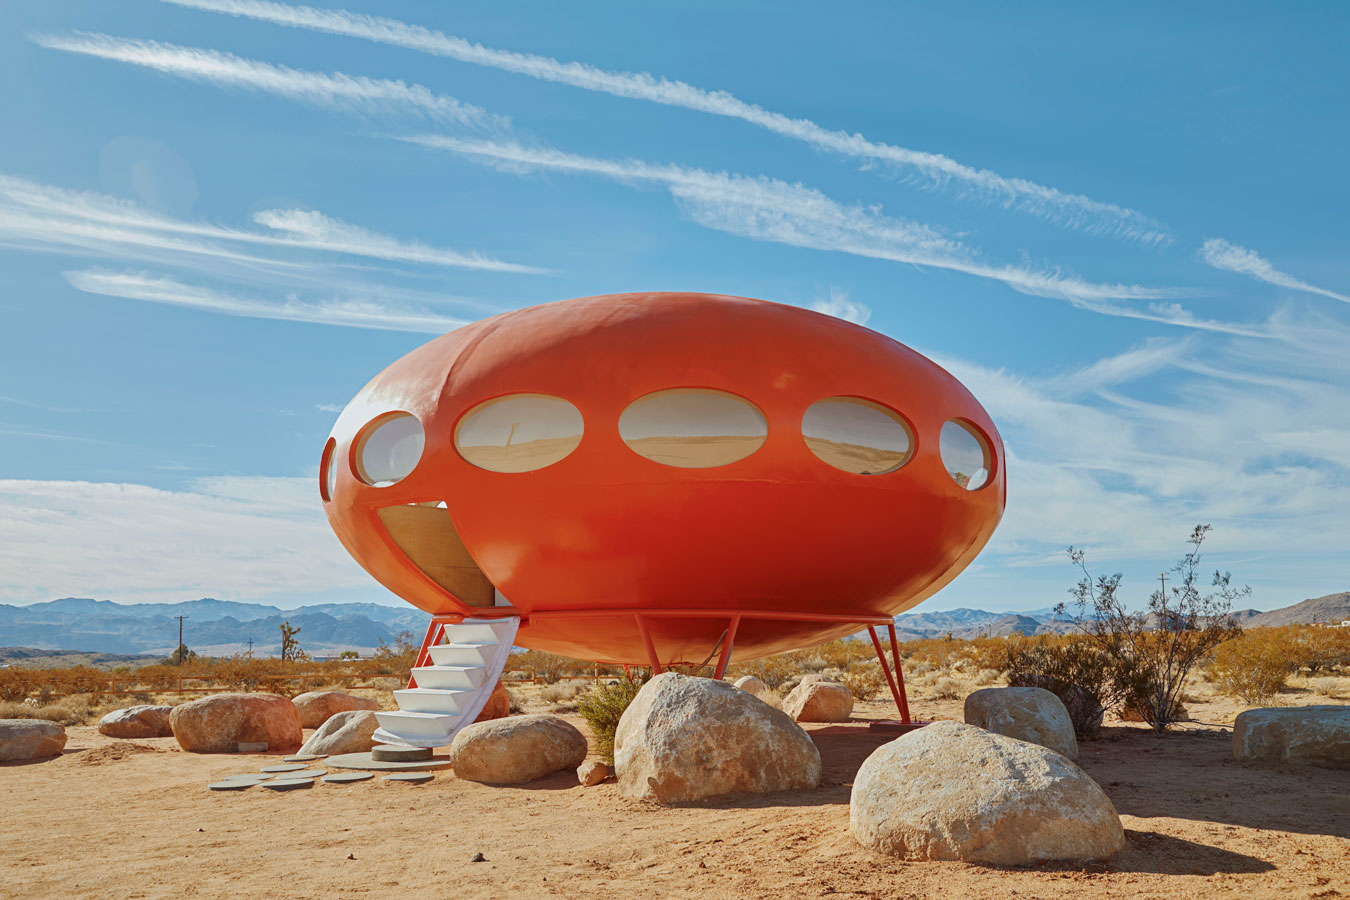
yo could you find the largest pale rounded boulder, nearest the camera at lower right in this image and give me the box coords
[849,722,1125,865]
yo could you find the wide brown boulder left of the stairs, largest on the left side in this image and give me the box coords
[169,694,302,753]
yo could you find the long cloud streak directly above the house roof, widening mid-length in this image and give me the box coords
[402,135,1264,337]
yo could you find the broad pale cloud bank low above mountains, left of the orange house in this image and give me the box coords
[0,476,370,602]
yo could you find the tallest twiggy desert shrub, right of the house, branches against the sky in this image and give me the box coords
[1057,525,1251,731]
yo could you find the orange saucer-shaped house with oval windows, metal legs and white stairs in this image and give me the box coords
[320,293,1006,745]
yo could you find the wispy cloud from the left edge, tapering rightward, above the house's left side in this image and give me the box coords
[0,174,544,273]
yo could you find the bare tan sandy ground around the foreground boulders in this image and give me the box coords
[0,699,1350,900]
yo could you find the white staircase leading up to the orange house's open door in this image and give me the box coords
[375,615,520,748]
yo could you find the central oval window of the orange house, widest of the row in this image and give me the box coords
[618,387,768,468]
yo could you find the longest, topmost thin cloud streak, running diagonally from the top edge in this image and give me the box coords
[165,0,1169,244]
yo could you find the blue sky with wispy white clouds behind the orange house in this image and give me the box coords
[0,0,1350,609]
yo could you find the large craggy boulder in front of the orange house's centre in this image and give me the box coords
[614,672,821,804]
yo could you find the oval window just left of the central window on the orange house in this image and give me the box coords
[455,394,585,472]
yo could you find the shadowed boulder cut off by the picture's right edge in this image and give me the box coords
[1233,706,1350,769]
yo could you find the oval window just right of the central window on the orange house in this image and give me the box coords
[802,397,914,475]
